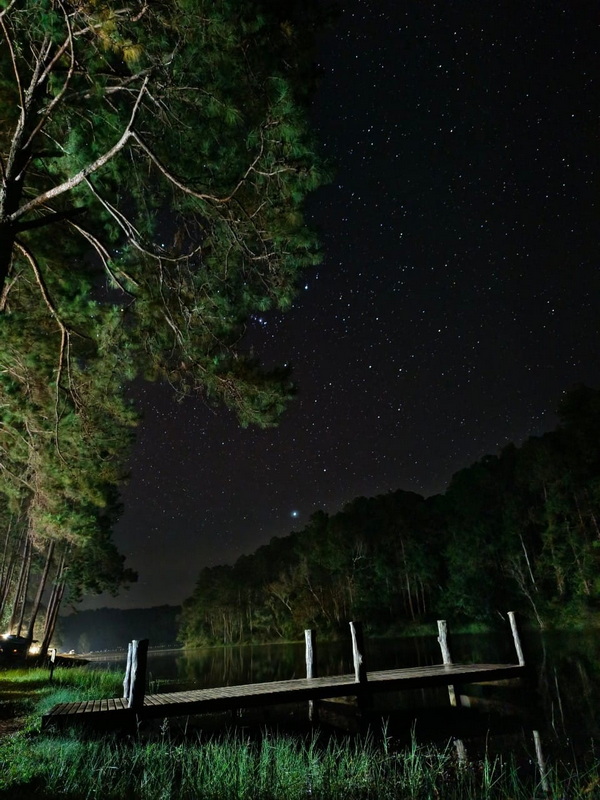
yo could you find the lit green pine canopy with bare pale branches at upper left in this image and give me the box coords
[0,0,322,624]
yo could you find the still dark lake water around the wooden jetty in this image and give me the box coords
[93,631,600,759]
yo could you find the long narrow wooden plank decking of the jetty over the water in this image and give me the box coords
[42,664,525,728]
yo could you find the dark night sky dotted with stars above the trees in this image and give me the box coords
[85,0,600,607]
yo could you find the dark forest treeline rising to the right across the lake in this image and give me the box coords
[179,386,600,646]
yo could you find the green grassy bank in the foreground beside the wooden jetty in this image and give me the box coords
[0,669,600,800]
